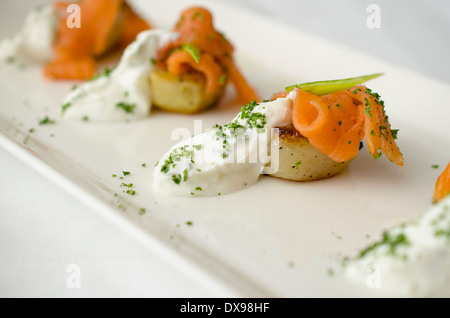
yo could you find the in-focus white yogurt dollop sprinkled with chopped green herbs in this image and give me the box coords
[153,93,293,196]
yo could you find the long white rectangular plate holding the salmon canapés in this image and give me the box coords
[0,0,450,297]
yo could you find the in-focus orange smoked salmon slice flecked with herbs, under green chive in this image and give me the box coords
[292,86,404,166]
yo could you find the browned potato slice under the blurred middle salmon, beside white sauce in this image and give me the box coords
[150,70,226,114]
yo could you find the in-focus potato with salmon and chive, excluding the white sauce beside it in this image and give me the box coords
[272,74,403,181]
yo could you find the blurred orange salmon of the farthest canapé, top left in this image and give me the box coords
[44,0,150,80]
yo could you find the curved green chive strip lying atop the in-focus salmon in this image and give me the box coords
[286,73,383,96]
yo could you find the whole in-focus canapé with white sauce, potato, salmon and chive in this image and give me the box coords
[153,74,403,196]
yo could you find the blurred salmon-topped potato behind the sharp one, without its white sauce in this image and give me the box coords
[150,7,258,113]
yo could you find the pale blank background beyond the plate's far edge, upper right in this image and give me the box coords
[227,0,450,82]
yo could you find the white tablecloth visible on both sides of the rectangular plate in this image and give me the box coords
[0,0,450,297]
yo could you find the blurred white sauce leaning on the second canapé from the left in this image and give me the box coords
[63,30,178,122]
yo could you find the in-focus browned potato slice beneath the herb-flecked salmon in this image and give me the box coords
[271,125,350,181]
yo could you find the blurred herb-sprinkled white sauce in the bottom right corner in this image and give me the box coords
[345,195,450,297]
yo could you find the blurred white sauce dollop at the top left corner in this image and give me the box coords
[0,5,58,64]
